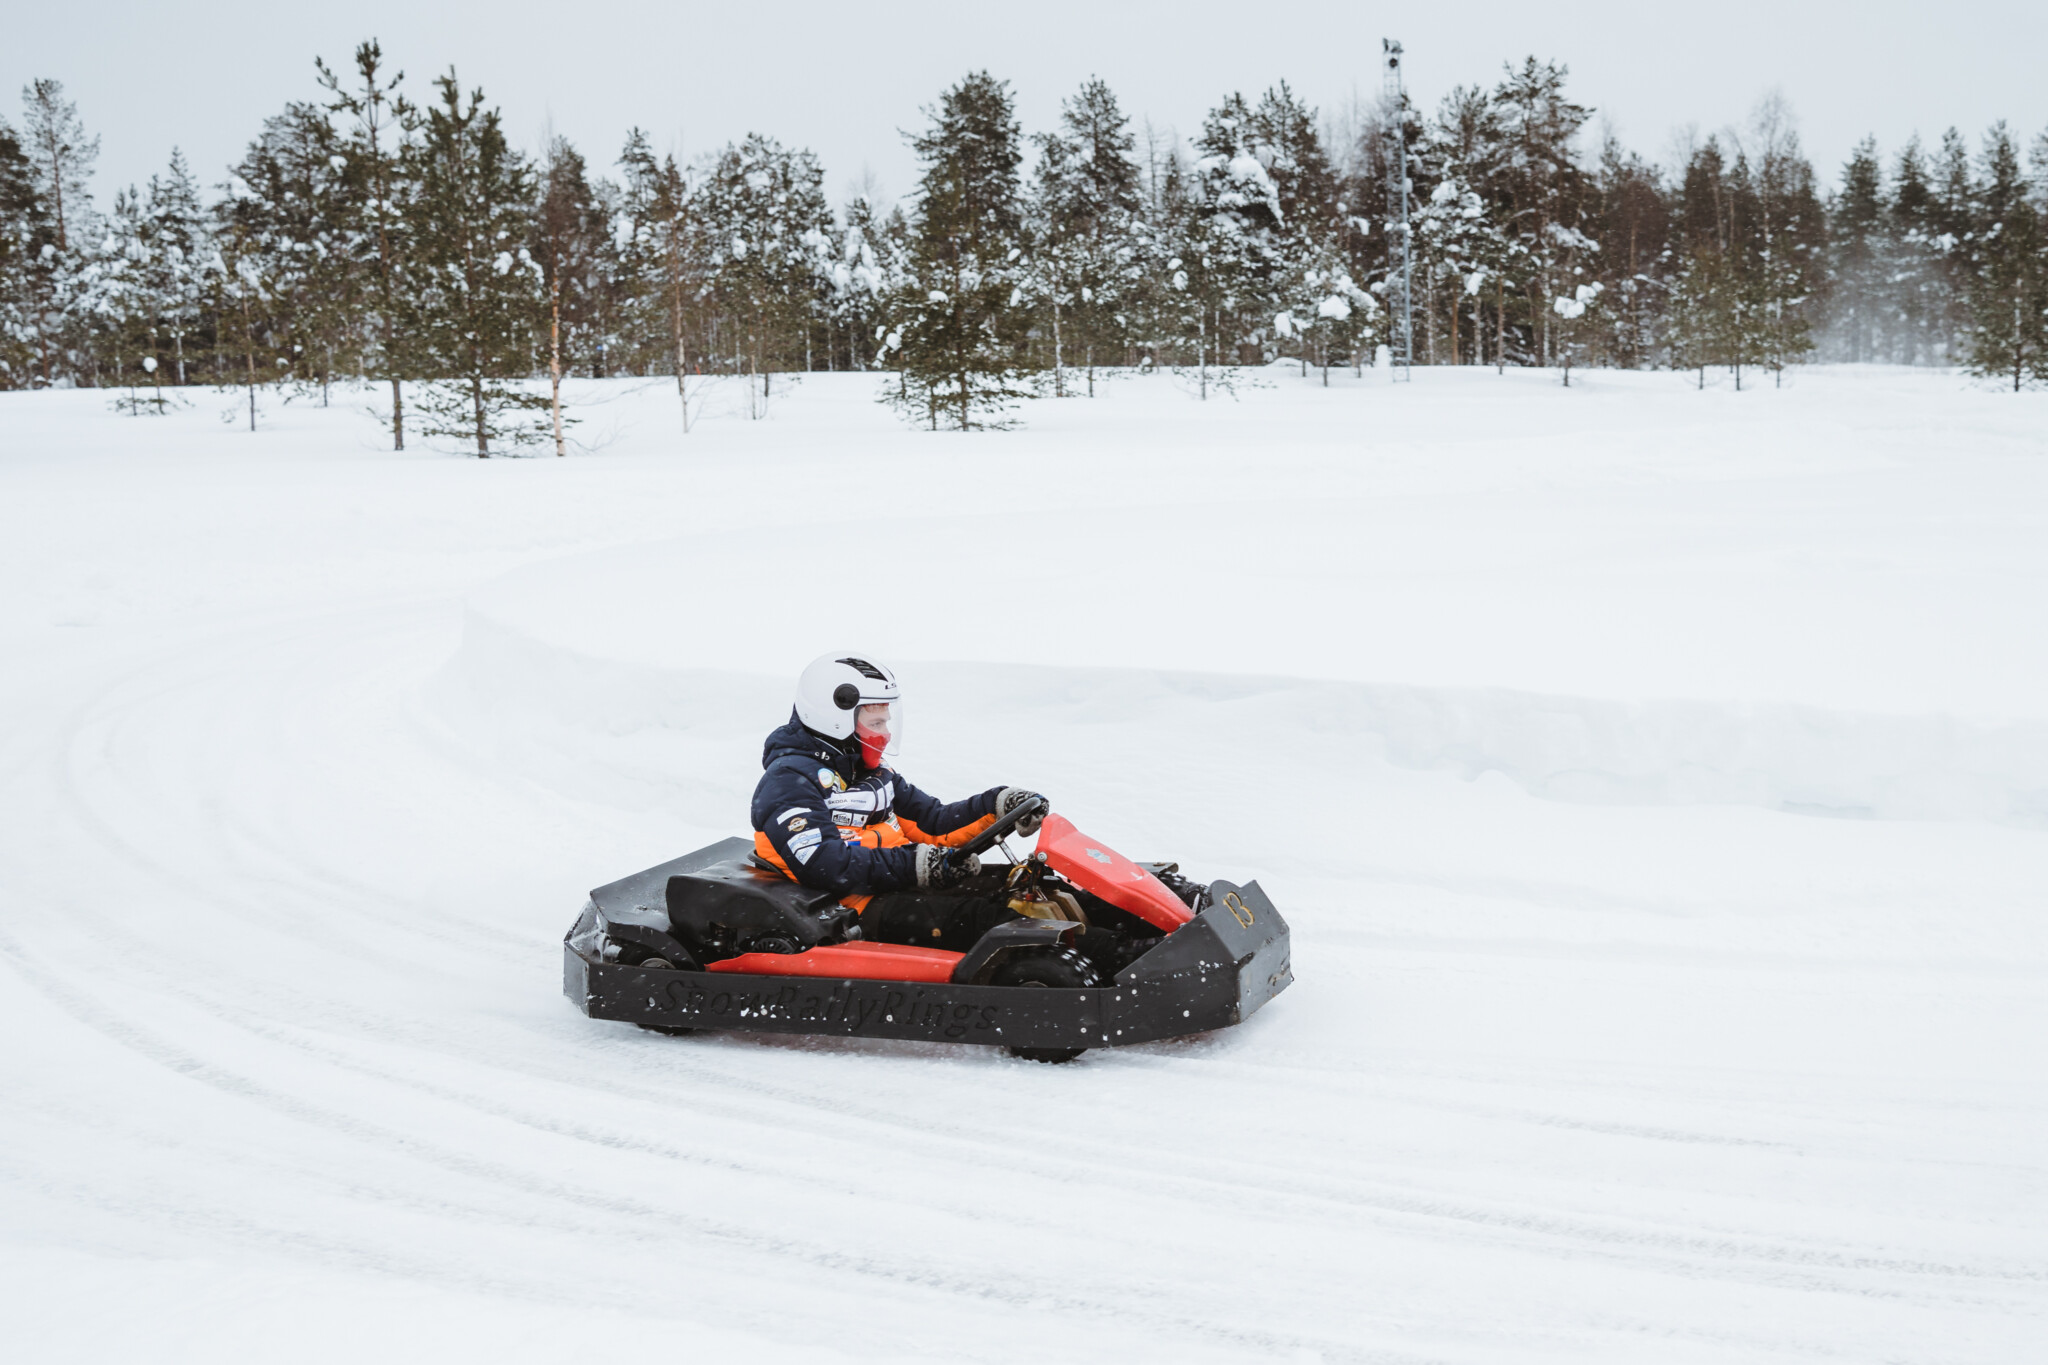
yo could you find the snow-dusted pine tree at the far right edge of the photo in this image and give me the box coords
[1970,121,2048,393]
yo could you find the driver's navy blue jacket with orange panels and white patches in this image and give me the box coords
[754,710,1001,896]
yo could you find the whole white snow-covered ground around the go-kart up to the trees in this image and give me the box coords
[0,370,2048,1363]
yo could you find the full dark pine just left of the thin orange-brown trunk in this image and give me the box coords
[406,70,549,458]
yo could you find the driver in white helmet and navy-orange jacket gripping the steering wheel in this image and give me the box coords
[754,655,1040,952]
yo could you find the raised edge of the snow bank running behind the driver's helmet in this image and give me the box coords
[436,602,2048,827]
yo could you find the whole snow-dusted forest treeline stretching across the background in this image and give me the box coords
[0,43,2048,444]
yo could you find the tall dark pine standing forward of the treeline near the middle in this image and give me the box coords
[887,72,1030,432]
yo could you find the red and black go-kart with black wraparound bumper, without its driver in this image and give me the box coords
[563,798,1294,1062]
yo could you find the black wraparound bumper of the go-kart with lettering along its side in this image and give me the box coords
[561,882,1294,1048]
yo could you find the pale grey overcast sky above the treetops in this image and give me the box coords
[0,0,2048,205]
